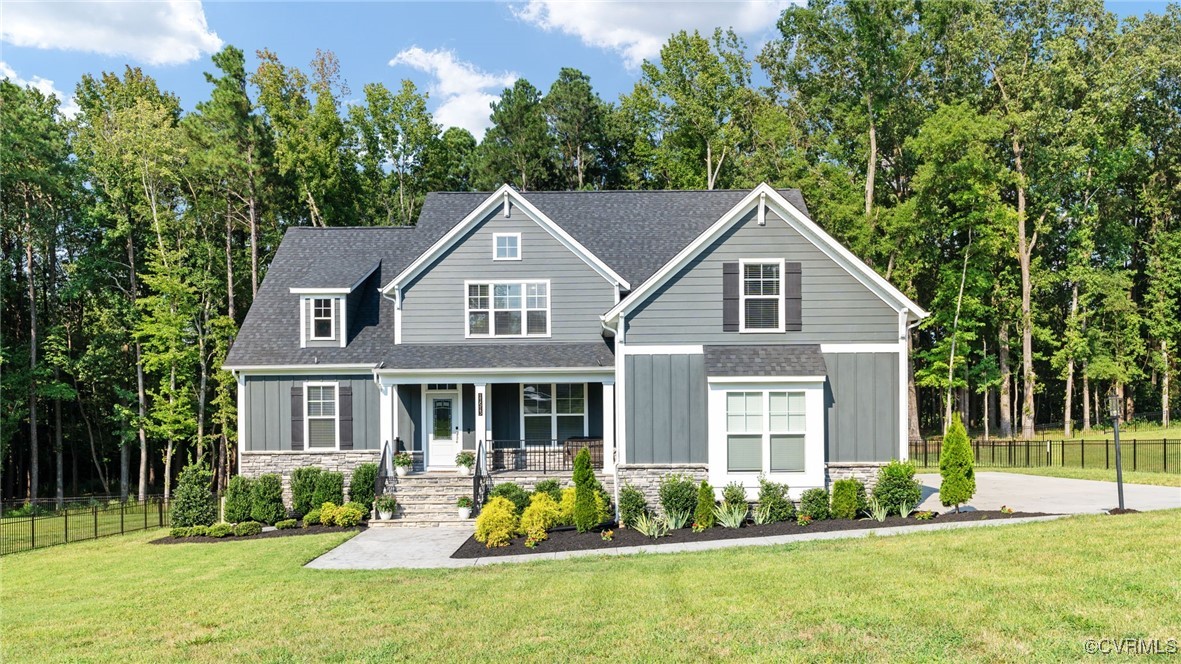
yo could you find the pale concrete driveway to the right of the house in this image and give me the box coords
[915,471,1181,514]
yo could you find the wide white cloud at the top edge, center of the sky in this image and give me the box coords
[513,0,791,69]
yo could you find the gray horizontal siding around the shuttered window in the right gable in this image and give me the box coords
[625,210,898,344]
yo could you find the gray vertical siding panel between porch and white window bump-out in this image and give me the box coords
[624,354,709,463]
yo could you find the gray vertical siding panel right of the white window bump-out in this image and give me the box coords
[824,353,900,462]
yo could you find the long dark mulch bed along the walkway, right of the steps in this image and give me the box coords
[451,510,1049,558]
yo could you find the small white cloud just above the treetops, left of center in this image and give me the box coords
[390,46,520,141]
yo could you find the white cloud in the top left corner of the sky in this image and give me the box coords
[0,0,222,65]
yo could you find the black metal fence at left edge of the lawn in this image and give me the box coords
[0,496,171,555]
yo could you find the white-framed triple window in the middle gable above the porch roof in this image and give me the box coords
[466,281,549,337]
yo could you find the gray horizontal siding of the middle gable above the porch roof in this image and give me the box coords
[402,207,615,344]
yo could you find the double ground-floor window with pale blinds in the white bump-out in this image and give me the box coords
[726,390,807,473]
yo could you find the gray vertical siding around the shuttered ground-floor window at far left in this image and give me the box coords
[243,375,381,454]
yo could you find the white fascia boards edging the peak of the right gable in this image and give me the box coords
[603,182,929,323]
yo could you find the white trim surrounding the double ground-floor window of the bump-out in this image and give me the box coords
[707,377,826,499]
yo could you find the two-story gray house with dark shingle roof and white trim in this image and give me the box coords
[219,184,927,519]
